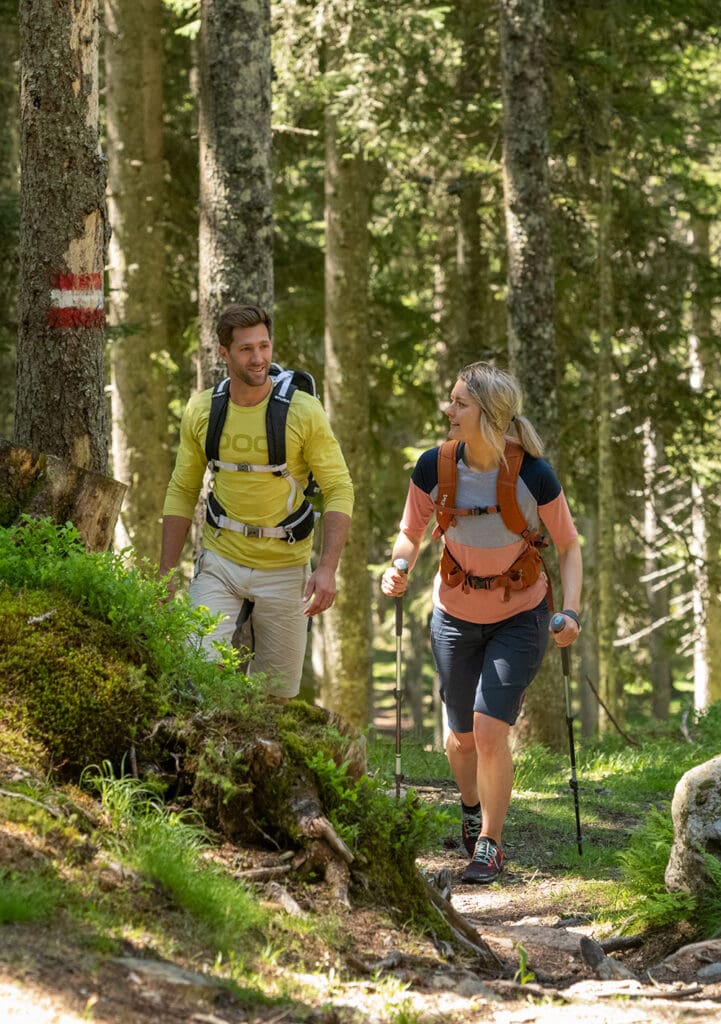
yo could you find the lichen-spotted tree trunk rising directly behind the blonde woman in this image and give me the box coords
[500,0,566,750]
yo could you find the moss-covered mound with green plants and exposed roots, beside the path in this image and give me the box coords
[0,520,450,933]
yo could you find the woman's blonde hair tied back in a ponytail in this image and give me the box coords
[458,362,543,460]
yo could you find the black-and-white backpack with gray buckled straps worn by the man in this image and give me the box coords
[205,362,319,544]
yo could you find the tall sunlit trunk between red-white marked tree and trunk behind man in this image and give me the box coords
[104,0,171,558]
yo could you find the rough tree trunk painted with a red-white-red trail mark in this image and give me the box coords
[14,0,108,473]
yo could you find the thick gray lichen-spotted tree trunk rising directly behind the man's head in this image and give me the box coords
[199,0,273,388]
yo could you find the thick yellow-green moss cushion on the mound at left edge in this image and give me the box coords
[0,588,172,774]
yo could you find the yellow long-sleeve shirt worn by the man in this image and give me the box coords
[163,388,353,568]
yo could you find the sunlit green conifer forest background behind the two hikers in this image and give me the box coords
[0,0,721,749]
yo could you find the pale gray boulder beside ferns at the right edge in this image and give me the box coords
[666,757,721,895]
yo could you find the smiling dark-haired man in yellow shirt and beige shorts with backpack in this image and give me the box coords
[160,304,353,698]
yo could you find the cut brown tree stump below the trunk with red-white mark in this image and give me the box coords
[0,438,127,551]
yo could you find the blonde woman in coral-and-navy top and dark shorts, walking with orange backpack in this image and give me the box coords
[381,362,583,884]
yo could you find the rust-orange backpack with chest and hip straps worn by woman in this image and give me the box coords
[433,437,553,608]
